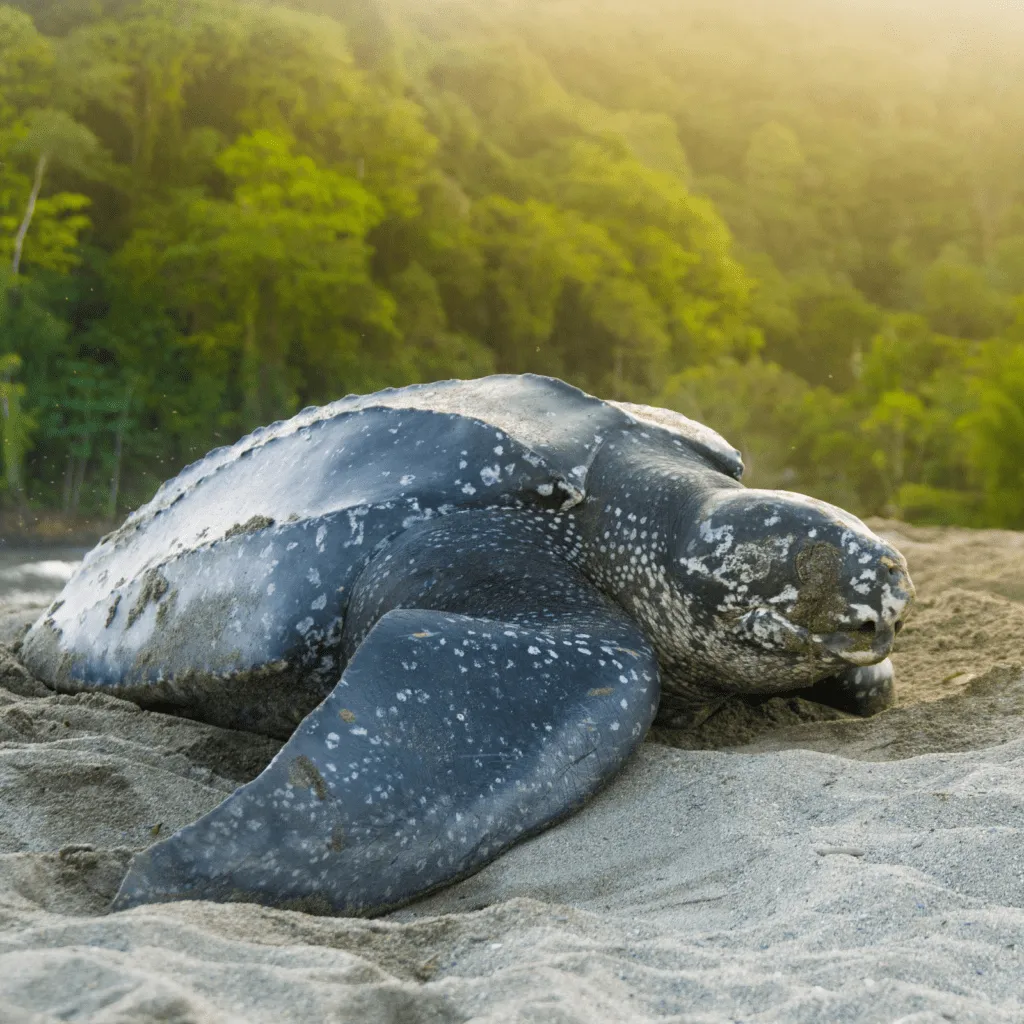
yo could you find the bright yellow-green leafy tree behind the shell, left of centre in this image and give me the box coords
[117,130,394,427]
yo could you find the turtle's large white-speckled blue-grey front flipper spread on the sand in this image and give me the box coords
[114,592,658,914]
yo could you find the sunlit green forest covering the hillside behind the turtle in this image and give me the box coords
[0,0,1024,528]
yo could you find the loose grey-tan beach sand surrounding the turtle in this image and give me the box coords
[0,523,1024,1024]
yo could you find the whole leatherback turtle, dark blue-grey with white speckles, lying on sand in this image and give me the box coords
[23,376,913,914]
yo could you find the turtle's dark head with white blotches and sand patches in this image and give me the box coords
[647,487,914,693]
